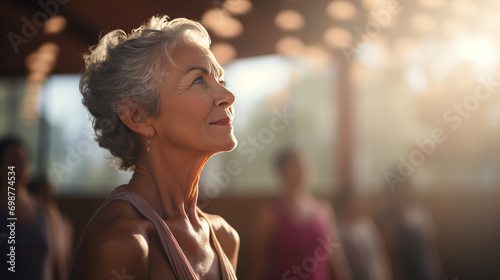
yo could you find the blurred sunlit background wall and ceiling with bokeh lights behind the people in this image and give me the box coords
[0,0,500,279]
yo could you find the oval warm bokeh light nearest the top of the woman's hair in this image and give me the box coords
[201,9,243,38]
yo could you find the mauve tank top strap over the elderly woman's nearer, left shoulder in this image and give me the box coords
[105,186,197,280]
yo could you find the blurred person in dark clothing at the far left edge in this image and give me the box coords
[0,137,61,280]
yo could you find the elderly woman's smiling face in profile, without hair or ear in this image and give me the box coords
[154,43,236,153]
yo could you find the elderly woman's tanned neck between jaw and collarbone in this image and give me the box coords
[127,149,210,220]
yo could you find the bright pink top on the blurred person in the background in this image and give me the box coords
[267,201,331,280]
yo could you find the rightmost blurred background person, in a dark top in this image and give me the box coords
[378,177,443,280]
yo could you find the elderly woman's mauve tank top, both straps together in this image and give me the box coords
[77,185,237,280]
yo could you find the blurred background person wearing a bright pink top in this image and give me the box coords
[248,148,350,280]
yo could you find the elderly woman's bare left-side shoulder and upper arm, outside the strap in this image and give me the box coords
[70,201,149,280]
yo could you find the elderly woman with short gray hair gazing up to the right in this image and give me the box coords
[70,16,239,280]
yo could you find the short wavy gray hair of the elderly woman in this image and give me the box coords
[80,16,223,170]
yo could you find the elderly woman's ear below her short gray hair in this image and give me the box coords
[117,98,155,137]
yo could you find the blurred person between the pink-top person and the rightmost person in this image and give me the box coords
[333,187,392,280]
